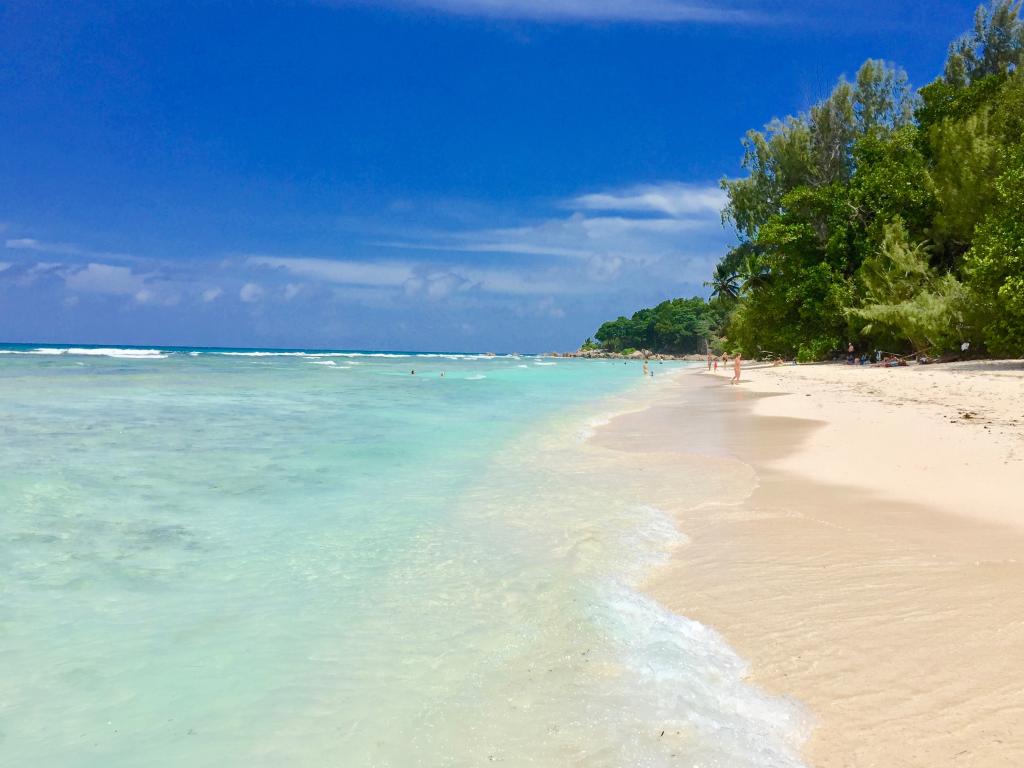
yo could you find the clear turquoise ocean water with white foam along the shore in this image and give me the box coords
[0,345,802,768]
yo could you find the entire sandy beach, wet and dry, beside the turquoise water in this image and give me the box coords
[594,361,1024,767]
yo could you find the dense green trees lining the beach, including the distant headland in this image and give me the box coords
[596,0,1024,360]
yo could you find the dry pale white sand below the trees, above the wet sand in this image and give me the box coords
[720,361,1024,532]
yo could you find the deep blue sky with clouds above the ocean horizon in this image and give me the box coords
[0,0,975,350]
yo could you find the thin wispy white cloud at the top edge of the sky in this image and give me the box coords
[348,0,759,24]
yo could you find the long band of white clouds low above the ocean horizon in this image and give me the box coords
[0,181,729,317]
